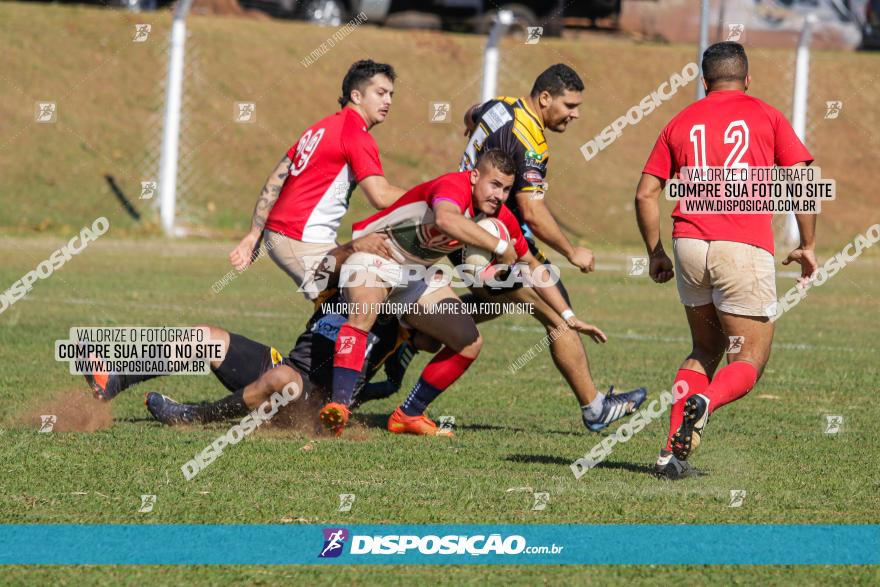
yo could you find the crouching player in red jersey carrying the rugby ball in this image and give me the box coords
[321,149,607,435]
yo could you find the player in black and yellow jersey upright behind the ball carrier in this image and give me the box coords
[416,64,646,431]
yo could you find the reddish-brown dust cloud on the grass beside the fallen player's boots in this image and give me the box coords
[14,389,113,432]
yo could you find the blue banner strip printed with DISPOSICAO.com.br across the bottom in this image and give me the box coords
[0,524,880,565]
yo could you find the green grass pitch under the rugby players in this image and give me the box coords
[0,236,880,584]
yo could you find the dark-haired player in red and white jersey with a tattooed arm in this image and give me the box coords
[229,59,404,299]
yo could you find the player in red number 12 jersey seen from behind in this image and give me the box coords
[636,42,817,479]
